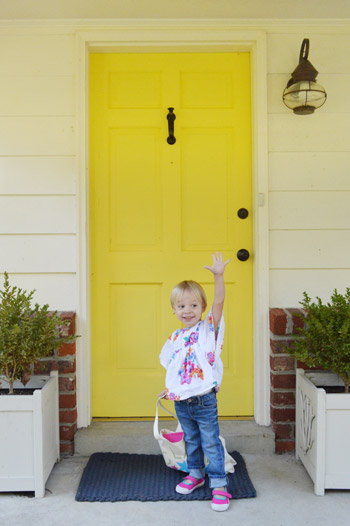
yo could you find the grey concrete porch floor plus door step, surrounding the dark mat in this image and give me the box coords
[0,420,349,526]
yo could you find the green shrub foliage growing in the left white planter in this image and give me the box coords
[0,272,76,394]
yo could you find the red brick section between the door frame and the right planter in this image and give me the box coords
[270,309,303,453]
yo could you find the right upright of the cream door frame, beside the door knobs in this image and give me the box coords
[252,35,270,425]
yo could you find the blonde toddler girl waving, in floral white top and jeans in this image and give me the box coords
[159,252,232,511]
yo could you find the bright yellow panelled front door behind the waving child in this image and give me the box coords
[90,53,253,417]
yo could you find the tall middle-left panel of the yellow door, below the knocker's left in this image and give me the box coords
[109,128,162,252]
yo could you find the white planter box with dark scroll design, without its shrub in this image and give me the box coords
[295,369,350,495]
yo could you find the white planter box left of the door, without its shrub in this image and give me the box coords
[0,371,59,497]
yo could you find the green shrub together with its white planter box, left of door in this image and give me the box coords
[0,272,75,497]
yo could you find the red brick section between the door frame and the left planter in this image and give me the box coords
[34,312,77,456]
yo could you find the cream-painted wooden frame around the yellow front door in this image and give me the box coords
[76,21,270,427]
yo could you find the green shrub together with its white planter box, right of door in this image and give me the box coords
[287,288,350,495]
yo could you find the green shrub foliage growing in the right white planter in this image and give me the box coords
[286,288,350,393]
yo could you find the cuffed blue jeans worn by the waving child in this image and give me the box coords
[175,391,227,488]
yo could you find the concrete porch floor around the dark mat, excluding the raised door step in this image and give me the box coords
[0,454,350,526]
